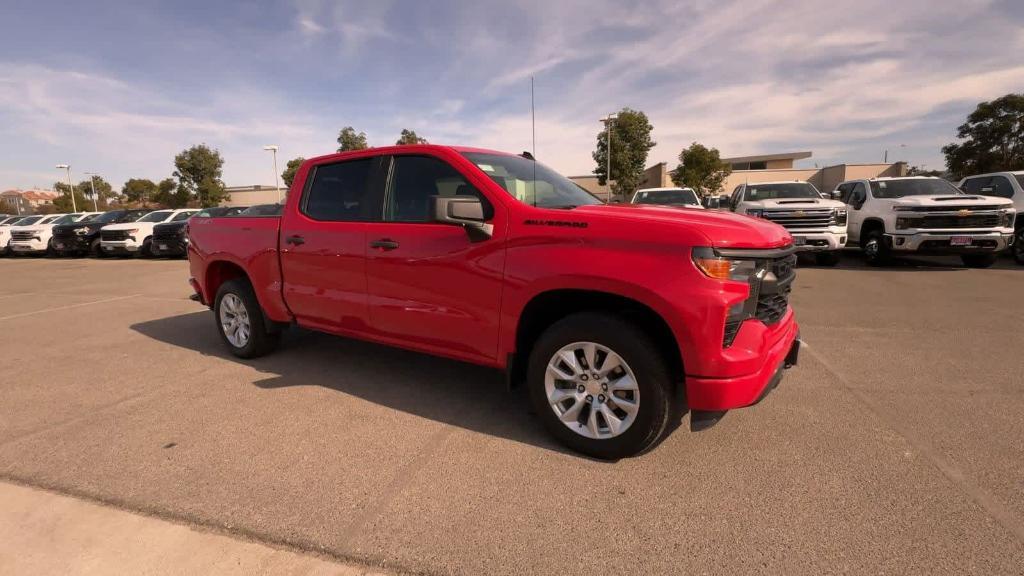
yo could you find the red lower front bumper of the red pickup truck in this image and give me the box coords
[686,313,801,411]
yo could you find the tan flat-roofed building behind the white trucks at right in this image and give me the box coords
[722,152,907,194]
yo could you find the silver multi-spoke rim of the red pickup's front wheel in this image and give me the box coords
[544,342,640,440]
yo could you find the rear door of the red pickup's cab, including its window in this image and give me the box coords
[280,156,381,334]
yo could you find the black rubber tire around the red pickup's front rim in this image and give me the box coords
[526,312,674,459]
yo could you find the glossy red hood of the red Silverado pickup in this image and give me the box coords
[567,204,793,248]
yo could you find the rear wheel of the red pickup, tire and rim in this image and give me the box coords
[213,279,281,358]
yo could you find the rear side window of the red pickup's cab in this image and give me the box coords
[302,158,375,222]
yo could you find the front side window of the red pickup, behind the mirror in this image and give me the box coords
[384,156,489,222]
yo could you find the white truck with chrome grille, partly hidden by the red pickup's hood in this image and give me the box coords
[729,180,847,266]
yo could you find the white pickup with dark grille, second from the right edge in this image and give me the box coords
[834,176,1016,268]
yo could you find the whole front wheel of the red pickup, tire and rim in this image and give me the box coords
[526,313,673,459]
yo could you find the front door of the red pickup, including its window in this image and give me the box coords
[366,153,507,363]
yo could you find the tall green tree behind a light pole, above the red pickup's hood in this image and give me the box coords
[593,108,656,198]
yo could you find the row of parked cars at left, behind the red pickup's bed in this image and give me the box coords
[0,204,280,258]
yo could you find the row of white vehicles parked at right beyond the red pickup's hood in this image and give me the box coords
[632,171,1024,268]
